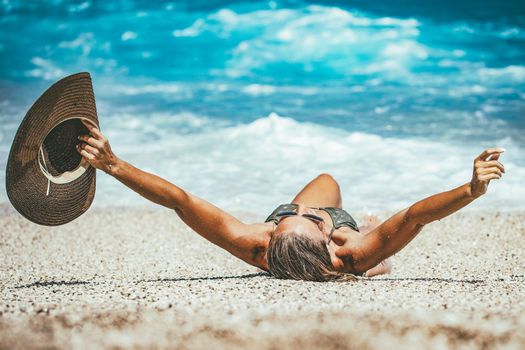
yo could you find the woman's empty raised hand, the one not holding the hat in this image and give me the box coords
[470,148,505,198]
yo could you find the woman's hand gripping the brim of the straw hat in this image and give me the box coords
[77,120,119,175]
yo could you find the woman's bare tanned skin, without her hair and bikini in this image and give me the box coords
[77,122,505,276]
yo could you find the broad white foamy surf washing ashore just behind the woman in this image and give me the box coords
[88,114,525,215]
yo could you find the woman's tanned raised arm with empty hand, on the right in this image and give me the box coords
[334,148,505,272]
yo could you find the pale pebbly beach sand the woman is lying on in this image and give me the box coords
[0,205,525,349]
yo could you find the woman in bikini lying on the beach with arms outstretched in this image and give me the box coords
[78,123,505,281]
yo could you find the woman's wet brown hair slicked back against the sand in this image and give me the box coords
[267,232,356,282]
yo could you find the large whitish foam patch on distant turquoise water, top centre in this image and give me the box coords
[173,5,422,77]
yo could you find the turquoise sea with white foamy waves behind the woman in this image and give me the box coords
[0,0,525,215]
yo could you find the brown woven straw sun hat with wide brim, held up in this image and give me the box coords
[6,73,98,226]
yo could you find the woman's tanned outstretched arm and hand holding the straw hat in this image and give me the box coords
[78,120,267,269]
